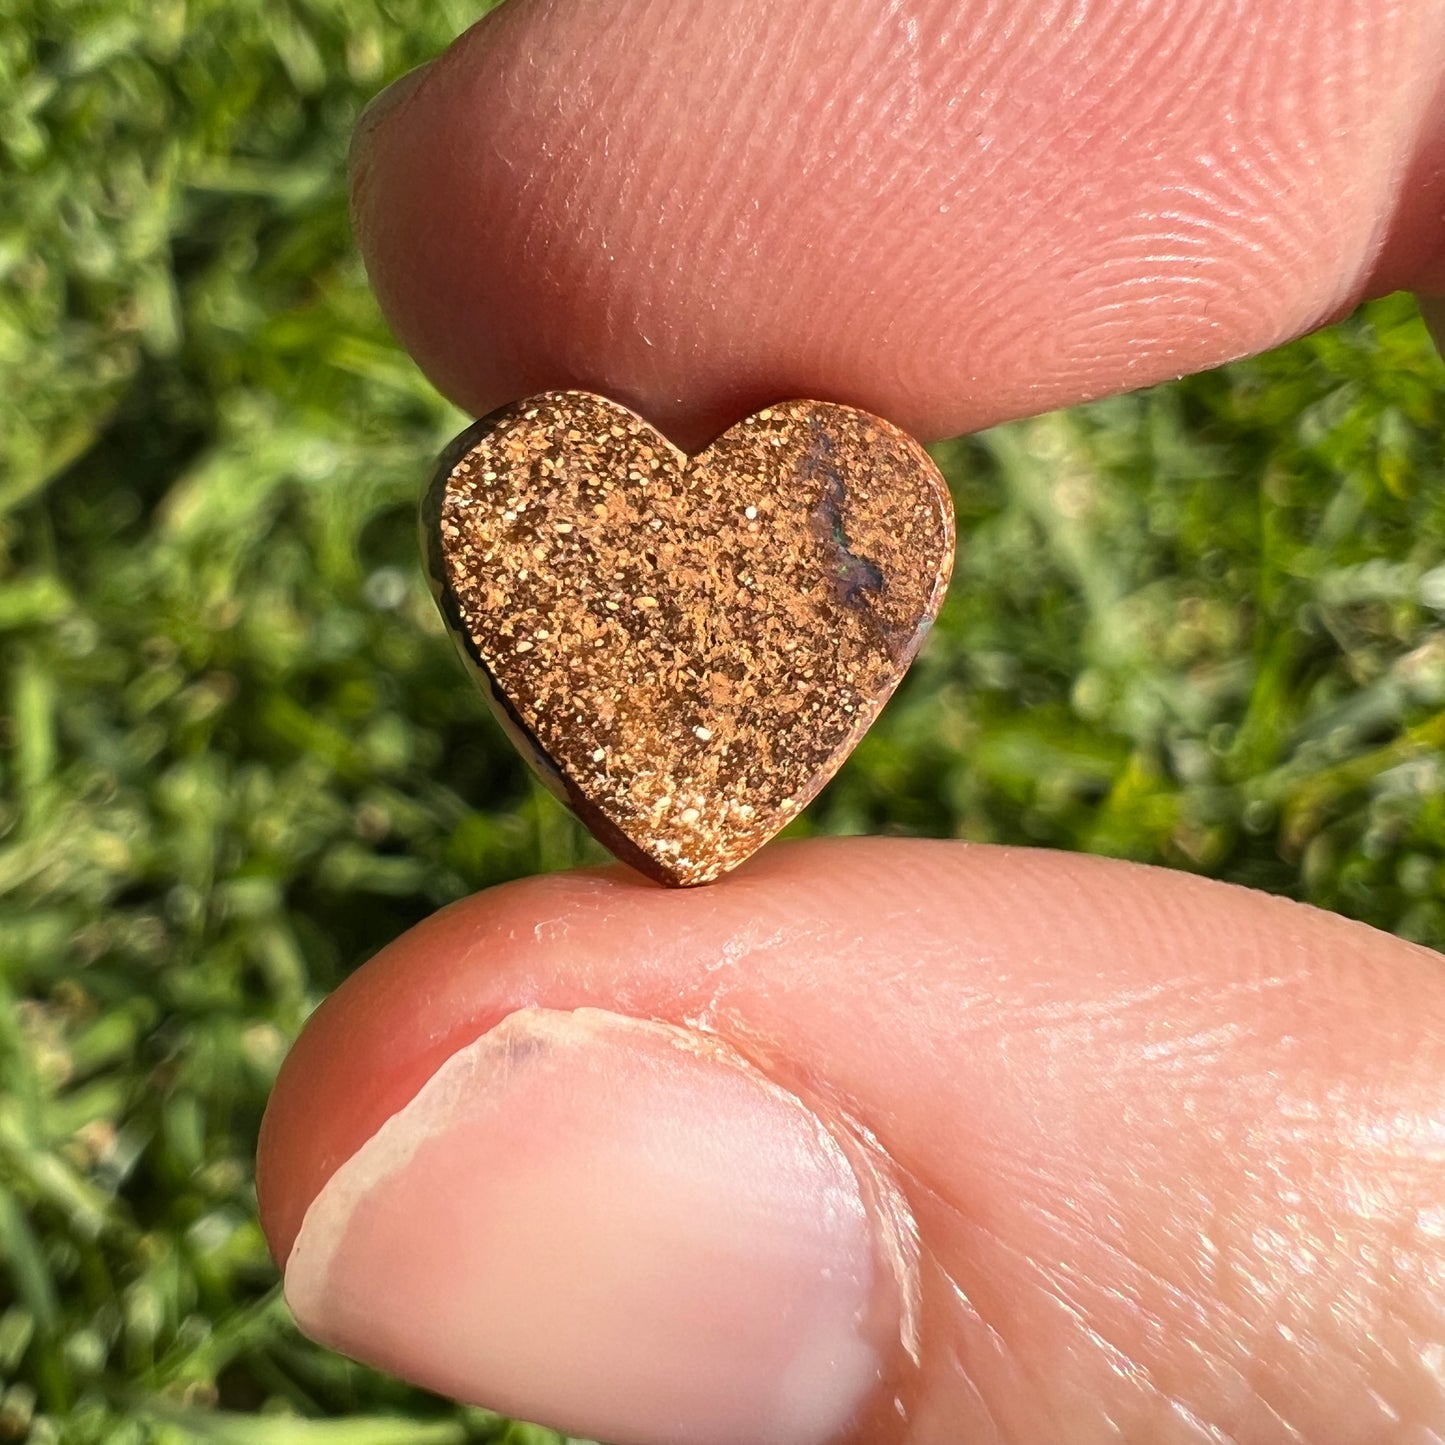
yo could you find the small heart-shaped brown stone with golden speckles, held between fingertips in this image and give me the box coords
[422,392,954,886]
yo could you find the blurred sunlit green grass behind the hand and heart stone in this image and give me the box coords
[0,0,1445,1445]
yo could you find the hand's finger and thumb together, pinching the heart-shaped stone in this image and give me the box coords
[262,0,1445,1445]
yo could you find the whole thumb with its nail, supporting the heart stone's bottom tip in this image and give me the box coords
[260,840,1445,1445]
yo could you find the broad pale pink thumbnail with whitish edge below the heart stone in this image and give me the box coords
[286,1009,899,1445]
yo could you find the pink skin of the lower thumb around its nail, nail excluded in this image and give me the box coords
[262,840,1445,1445]
